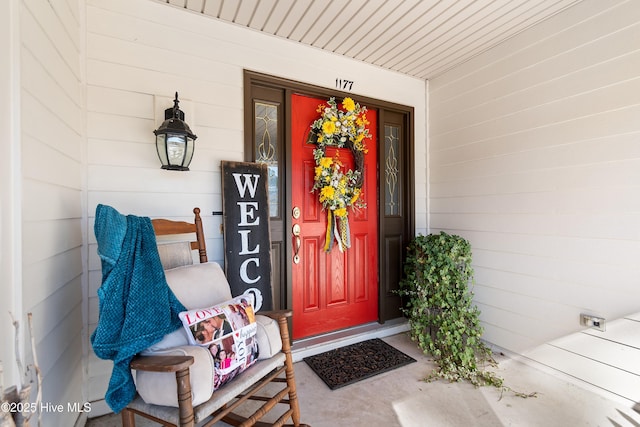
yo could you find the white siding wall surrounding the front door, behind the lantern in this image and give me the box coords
[87,0,427,416]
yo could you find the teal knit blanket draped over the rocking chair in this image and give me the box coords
[91,205,186,413]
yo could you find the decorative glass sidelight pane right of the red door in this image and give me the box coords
[383,125,402,216]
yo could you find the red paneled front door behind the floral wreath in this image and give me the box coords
[291,95,378,339]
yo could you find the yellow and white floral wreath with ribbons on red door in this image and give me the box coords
[311,98,371,252]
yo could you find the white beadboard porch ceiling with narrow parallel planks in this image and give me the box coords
[154,0,582,79]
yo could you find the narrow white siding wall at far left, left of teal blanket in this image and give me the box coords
[20,0,86,427]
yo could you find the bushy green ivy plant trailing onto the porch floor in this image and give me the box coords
[398,232,530,397]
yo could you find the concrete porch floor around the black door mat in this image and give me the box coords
[86,333,640,427]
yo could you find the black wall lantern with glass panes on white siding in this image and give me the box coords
[153,92,197,171]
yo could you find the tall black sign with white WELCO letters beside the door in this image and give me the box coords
[221,161,273,311]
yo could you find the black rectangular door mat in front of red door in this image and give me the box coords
[304,338,416,390]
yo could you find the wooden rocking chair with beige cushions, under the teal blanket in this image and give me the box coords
[122,208,304,427]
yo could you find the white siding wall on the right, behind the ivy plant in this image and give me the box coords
[429,0,640,402]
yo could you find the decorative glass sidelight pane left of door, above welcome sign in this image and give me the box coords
[254,102,280,217]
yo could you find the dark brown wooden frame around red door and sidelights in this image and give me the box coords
[244,70,415,322]
